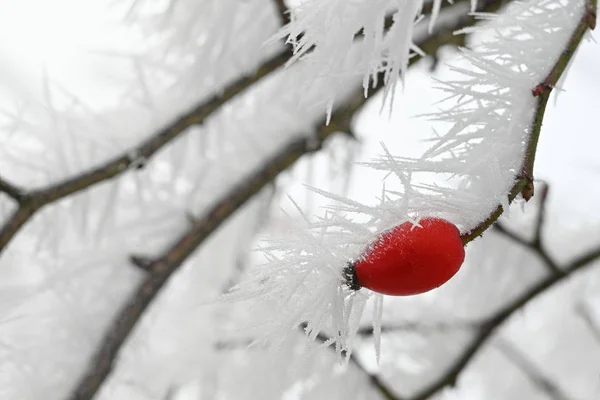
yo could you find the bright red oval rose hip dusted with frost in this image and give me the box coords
[354,218,465,296]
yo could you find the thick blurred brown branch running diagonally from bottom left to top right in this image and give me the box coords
[71,2,497,400]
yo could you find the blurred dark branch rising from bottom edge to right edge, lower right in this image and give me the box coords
[411,241,600,400]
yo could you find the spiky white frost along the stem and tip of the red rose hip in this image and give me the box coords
[230,0,584,355]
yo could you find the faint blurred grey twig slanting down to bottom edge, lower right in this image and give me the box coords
[494,339,571,400]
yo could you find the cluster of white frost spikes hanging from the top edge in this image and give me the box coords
[276,0,426,102]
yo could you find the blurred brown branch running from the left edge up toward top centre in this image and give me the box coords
[0,50,291,255]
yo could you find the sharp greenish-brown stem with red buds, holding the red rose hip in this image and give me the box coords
[462,0,597,244]
